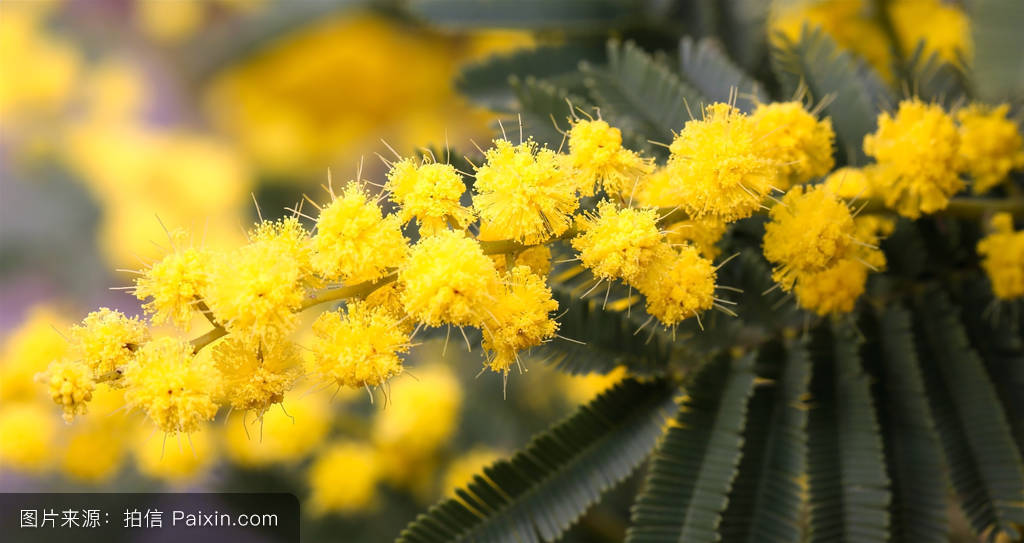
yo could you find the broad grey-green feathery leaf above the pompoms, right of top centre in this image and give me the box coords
[583,41,705,142]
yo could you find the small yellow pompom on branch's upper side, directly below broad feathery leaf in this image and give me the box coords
[567,119,653,196]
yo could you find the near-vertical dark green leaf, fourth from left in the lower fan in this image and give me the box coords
[807,325,890,543]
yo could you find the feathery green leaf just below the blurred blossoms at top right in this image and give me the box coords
[772,27,893,165]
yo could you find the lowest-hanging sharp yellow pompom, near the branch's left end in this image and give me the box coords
[125,337,221,433]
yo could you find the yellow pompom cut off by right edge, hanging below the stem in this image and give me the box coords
[978,213,1024,300]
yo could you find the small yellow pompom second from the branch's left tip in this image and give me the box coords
[71,307,150,376]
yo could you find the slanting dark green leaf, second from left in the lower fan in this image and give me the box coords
[626,356,754,543]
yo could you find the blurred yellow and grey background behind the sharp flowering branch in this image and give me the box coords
[0,0,991,541]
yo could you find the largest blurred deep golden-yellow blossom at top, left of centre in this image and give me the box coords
[206,12,531,175]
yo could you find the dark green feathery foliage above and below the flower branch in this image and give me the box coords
[406,0,1024,543]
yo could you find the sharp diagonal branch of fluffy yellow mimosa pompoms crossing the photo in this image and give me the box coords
[36,99,1024,438]
